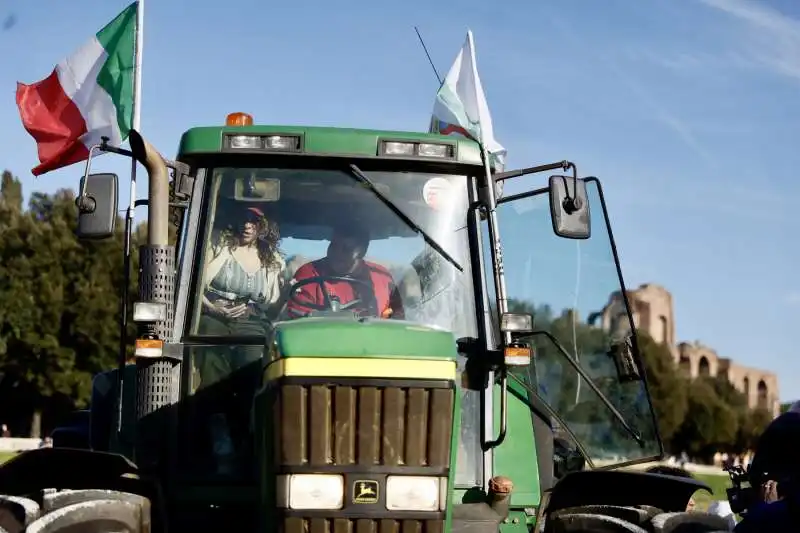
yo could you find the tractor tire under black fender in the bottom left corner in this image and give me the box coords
[0,489,151,533]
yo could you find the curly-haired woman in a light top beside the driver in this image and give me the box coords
[195,207,285,474]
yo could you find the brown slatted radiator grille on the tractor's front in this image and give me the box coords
[275,382,455,468]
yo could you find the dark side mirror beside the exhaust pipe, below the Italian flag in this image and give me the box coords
[75,174,119,240]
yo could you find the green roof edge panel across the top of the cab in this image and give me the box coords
[178,125,481,165]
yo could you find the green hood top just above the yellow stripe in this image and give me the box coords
[275,317,458,361]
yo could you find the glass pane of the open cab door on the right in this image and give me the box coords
[488,180,661,466]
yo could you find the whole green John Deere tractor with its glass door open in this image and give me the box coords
[0,113,725,533]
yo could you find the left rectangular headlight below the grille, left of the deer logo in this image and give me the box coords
[277,474,344,509]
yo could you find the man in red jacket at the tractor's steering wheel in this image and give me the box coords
[287,224,405,319]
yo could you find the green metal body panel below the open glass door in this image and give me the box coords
[493,380,542,507]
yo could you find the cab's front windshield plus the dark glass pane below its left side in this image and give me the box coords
[178,159,477,482]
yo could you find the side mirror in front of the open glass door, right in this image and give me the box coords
[550,176,592,239]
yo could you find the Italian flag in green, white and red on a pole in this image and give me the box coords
[17,2,138,176]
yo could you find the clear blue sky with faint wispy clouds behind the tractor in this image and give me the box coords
[0,0,800,400]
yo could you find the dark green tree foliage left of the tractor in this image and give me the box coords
[0,172,139,435]
